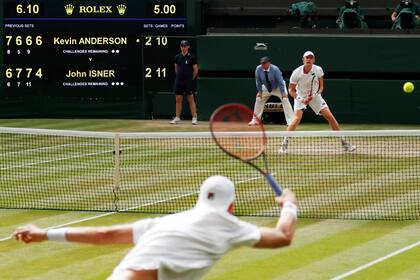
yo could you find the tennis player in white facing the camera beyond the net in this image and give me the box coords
[279,51,356,154]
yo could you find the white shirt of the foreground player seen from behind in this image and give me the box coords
[113,206,261,280]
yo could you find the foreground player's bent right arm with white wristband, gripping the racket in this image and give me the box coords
[254,189,297,248]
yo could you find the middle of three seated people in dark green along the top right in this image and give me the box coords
[336,0,368,30]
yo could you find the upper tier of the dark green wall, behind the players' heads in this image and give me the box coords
[197,34,420,73]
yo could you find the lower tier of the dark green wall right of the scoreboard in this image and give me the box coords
[199,78,420,124]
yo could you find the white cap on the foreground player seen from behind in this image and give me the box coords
[197,176,235,211]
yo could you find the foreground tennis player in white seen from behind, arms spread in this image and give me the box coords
[13,176,297,280]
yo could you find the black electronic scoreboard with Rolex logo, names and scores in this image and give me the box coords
[0,0,194,115]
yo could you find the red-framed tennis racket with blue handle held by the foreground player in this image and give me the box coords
[210,103,282,196]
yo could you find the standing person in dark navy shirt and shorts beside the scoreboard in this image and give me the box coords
[171,40,198,125]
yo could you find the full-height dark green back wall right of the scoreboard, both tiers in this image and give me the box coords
[197,35,420,124]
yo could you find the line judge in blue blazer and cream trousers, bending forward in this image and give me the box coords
[248,56,294,125]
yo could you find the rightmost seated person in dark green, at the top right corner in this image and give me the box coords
[391,0,420,29]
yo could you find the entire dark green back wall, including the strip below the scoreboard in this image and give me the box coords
[0,33,420,124]
